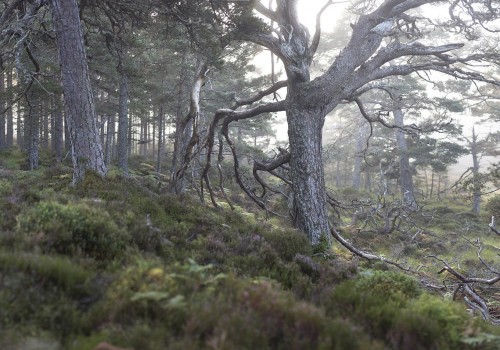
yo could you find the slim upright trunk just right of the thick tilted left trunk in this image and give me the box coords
[116,69,129,174]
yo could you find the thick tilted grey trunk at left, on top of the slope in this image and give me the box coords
[50,0,107,184]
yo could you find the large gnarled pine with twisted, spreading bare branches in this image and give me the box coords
[198,0,500,244]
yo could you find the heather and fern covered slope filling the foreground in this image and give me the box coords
[0,155,500,350]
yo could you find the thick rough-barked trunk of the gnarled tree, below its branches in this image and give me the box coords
[286,104,330,244]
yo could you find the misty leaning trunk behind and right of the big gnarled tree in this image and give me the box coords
[393,109,416,206]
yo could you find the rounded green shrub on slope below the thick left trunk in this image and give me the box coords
[17,201,128,260]
